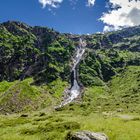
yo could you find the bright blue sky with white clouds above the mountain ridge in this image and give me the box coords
[0,0,140,34]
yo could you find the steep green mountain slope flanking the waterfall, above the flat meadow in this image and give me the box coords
[0,21,140,113]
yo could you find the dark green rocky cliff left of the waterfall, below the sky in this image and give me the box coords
[0,22,74,83]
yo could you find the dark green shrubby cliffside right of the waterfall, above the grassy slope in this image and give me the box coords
[79,44,140,86]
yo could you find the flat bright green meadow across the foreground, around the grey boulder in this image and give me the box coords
[0,108,140,140]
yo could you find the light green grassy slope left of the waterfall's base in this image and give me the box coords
[0,78,68,113]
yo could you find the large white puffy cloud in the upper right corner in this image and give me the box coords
[100,0,140,31]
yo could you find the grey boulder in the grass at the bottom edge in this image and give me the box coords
[66,131,109,140]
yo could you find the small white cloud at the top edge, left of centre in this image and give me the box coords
[39,0,63,8]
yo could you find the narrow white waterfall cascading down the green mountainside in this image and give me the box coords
[59,38,86,107]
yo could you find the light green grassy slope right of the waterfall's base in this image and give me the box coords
[80,66,140,113]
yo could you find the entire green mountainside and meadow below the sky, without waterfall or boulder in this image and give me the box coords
[0,21,140,140]
